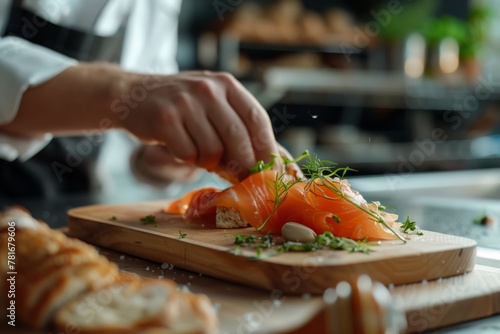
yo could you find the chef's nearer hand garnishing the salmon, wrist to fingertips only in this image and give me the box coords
[121,72,280,183]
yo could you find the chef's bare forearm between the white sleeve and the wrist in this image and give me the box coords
[0,64,132,137]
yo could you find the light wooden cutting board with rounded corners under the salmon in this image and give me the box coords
[68,201,476,294]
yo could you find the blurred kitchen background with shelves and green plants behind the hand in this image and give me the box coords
[169,0,500,175]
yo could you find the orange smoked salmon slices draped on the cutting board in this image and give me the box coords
[165,171,398,240]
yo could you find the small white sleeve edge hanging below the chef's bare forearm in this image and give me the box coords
[0,133,52,161]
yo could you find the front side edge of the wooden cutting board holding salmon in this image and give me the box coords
[68,211,476,294]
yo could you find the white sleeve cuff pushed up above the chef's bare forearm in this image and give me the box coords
[0,37,77,124]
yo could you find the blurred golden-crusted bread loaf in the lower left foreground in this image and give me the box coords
[0,208,217,333]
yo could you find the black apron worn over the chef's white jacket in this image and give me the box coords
[0,0,126,200]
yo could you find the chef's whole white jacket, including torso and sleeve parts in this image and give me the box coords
[0,0,181,161]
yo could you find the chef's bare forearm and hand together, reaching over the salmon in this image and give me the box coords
[6,63,279,180]
